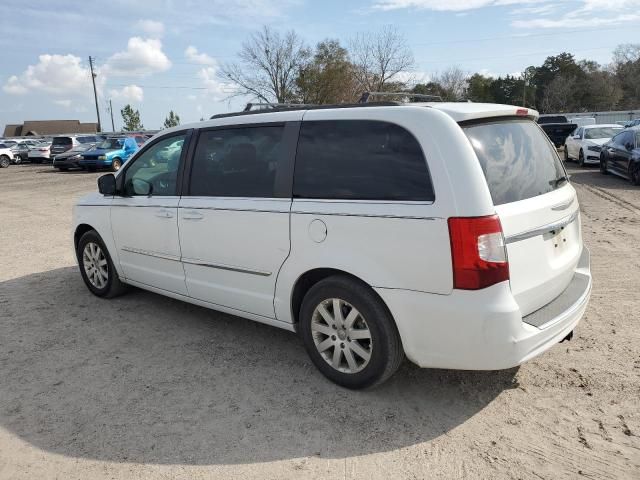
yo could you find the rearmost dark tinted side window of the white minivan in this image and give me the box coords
[293,120,434,201]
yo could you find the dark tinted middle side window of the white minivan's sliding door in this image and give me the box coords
[189,125,284,198]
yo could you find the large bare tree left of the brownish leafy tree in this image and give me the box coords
[219,26,310,103]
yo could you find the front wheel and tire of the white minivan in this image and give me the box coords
[76,230,127,298]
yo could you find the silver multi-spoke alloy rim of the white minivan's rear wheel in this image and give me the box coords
[311,298,373,373]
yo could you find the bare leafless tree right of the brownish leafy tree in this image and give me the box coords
[349,26,415,92]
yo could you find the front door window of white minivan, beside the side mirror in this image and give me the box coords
[124,133,186,196]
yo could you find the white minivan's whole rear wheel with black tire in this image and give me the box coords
[299,275,404,389]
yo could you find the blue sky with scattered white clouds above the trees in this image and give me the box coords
[0,0,640,132]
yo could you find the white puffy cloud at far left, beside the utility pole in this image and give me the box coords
[3,54,91,95]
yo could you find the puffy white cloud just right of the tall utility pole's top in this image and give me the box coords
[101,37,171,76]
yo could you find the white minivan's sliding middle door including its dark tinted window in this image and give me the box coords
[178,124,297,318]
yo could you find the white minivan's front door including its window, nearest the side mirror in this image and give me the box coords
[111,132,188,295]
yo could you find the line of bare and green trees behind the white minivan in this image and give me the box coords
[219,26,640,113]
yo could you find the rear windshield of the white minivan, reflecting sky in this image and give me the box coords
[464,119,567,205]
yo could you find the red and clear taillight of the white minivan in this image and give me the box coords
[449,215,509,290]
